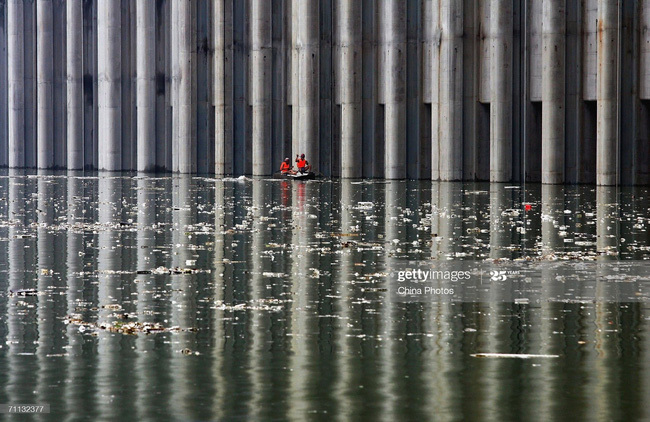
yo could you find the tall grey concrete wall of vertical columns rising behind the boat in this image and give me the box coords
[0,0,650,185]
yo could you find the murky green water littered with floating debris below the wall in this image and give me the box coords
[0,173,650,421]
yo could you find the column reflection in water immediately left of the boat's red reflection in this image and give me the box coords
[249,179,272,419]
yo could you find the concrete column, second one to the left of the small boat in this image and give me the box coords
[212,0,233,175]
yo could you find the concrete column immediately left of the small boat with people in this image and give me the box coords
[249,0,272,176]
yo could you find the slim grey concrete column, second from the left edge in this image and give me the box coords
[36,0,54,169]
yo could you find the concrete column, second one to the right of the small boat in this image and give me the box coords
[381,0,406,179]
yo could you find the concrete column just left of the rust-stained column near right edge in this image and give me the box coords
[542,0,566,183]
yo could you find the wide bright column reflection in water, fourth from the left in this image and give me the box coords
[96,173,122,419]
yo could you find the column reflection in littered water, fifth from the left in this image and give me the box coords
[135,176,156,420]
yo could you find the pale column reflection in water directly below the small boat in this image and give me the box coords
[288,182,319,420]
